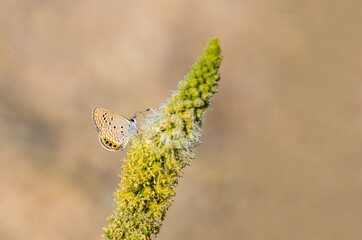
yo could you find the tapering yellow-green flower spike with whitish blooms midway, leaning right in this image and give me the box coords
[103,38,221,240]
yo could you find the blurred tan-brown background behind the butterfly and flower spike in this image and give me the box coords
[0,0,362,240]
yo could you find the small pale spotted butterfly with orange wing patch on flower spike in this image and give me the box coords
[92,108,149,151]
